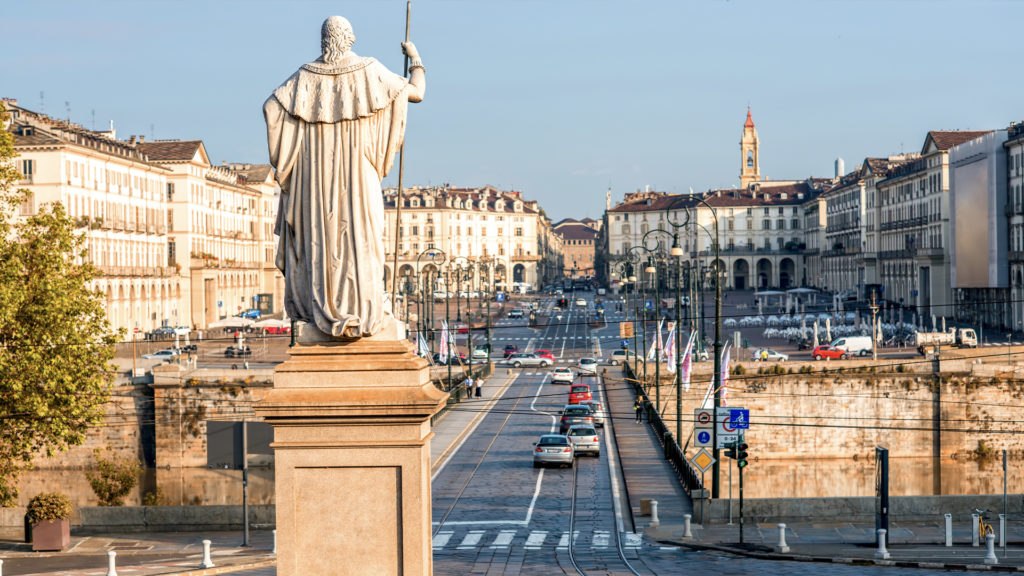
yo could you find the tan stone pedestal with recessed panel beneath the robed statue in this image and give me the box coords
[256,336,446,576]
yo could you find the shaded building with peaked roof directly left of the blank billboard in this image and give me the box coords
[876,130,988,318]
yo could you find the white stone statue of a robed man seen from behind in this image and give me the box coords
[263,16,426,340]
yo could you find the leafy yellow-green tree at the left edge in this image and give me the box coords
[0,104,119,506]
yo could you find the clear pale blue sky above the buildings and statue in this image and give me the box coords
[0,0,1024,220]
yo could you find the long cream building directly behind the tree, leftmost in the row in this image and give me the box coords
[4,99,180,333]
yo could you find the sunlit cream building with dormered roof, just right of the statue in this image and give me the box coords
[384,186,562,291]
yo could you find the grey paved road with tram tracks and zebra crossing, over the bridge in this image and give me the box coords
[432,293,942,575]
